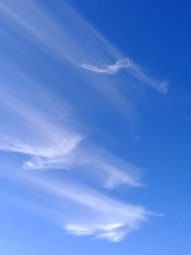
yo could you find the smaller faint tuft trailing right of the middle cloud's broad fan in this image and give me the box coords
[78,144,142,189]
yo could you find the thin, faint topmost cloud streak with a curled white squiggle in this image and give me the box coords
[0,0,167,93]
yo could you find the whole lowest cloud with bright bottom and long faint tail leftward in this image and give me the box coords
[0,165,148,242]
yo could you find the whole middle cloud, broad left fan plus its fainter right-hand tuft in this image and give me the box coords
[0,69,141,189]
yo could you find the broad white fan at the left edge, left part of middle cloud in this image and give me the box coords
[0,75,83,167]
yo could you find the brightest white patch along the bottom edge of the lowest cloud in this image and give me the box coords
[65,204,147,242]
